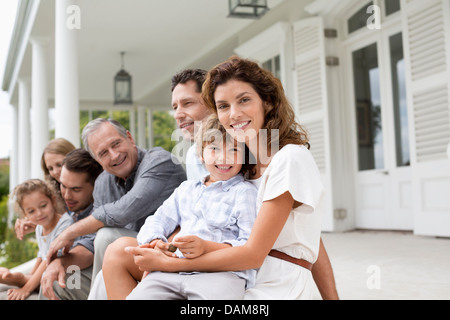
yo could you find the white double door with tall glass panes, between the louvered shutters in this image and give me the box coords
[346,26,414,230]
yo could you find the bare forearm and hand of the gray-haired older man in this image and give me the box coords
[47,216,104,261]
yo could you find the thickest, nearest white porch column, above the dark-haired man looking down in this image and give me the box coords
[55,0,80,147]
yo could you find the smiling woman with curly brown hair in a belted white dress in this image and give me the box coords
[128,57,324,299]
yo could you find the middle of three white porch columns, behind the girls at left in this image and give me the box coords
[31,38,49,179]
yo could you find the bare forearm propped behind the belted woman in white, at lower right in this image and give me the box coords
[312,238,339,300]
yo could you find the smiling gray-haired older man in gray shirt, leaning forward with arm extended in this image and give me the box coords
[48,118,186,282]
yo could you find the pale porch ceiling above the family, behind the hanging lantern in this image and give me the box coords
[21,0,284,107]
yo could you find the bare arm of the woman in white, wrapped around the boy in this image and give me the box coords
[127,192,294,272]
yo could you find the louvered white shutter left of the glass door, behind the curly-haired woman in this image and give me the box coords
[293,17,333,230]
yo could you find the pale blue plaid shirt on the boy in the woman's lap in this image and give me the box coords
[137,174,257,288]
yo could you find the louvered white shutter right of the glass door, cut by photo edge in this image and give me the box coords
[402,0,450,236]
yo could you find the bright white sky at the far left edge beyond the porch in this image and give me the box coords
[0,0,18,158]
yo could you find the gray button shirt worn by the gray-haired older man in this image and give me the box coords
[92,147,186,231]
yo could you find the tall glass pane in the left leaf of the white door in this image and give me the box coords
[352,43,385,171]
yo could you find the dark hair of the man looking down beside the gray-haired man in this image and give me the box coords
[62,148,103,185]
